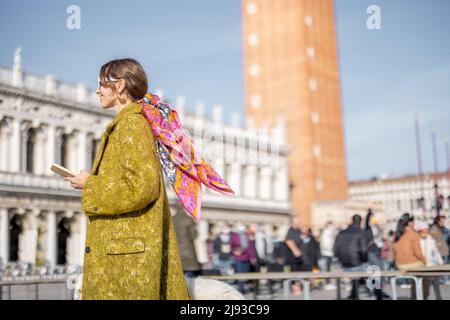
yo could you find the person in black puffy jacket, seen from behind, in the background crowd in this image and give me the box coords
[334,214,367,300]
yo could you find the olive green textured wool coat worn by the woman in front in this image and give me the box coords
[82,103,189,299]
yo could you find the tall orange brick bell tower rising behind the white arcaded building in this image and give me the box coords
[242,0,347,226]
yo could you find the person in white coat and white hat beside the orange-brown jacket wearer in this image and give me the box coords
[414,221,444,300]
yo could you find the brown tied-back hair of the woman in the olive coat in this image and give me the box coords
[99,58,148,100]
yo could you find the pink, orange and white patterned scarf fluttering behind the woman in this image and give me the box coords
[138,93,234,220]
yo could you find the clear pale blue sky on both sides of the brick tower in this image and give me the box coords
[0,0,450,180]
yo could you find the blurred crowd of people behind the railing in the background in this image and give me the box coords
[173,209,450,300]
